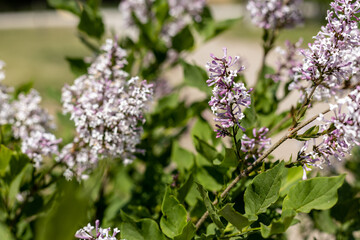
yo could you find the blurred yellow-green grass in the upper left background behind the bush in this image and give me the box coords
[0,28,91,104]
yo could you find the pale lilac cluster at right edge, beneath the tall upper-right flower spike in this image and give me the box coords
[298,86,360,176]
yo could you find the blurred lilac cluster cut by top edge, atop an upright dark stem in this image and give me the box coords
[246,0,303,30]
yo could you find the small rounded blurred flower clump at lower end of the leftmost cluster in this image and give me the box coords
[21,131,61,168]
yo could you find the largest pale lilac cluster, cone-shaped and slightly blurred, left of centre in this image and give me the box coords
[58,39,153,179]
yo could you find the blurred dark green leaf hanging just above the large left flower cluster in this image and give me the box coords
[78,5,105,39]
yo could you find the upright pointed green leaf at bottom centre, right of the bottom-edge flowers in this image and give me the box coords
[160,188,187,238]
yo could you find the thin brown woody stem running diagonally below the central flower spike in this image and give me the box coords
[196,109,330,230]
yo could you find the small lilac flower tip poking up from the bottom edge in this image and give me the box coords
[75,220,120,240]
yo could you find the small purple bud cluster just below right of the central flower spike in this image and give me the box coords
[241,127,271,160]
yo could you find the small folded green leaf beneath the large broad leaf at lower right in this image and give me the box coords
[260,209,296,238]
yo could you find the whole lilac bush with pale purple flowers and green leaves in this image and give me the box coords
[0,0,360,240]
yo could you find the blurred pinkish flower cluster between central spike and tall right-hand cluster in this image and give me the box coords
[266,39,303,83]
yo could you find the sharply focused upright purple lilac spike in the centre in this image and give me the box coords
[206,48,251,137]
